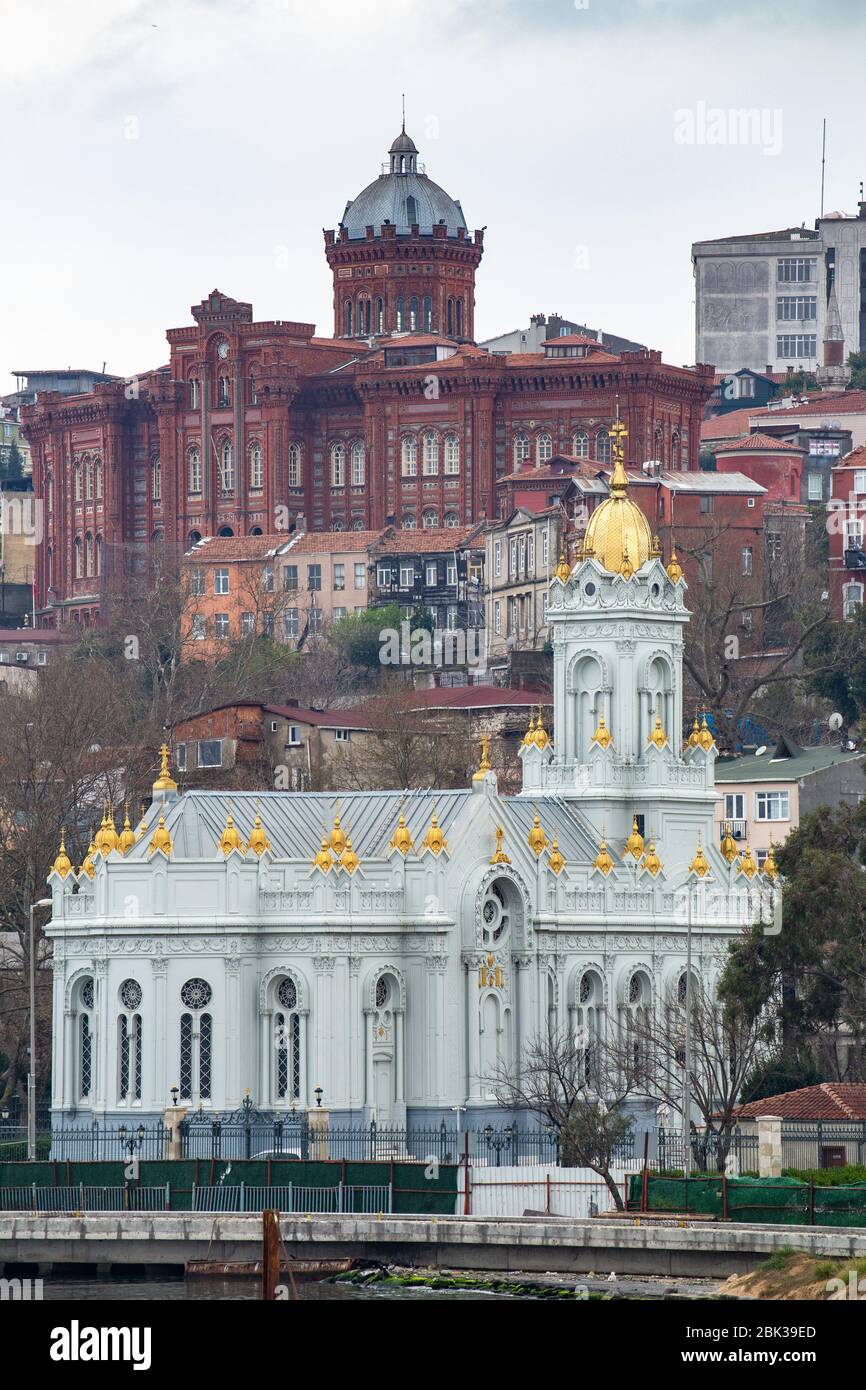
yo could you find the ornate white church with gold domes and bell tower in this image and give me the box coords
[47,430,760,1126]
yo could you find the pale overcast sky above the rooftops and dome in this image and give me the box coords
[0,0,866,391]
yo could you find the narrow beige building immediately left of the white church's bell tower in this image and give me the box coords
[485,503,563,673]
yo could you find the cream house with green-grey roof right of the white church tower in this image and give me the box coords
[716,735,866,863]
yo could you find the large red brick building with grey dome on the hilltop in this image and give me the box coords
[22,132,713,627]
